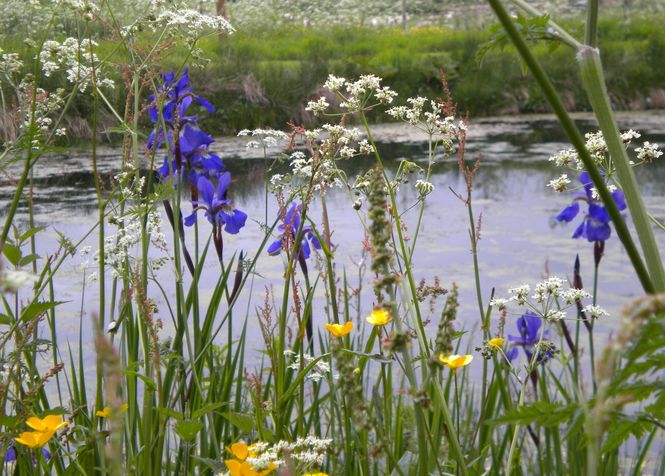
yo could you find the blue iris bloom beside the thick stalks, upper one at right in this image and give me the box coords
[556,172,626,242]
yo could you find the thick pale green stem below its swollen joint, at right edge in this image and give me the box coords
[577,46,665,292]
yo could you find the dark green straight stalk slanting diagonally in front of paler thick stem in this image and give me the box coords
[487,0,654,293]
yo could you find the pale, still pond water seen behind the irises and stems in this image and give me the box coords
[0,113,665,364]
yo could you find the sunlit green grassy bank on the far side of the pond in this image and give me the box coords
[5,16,665,137]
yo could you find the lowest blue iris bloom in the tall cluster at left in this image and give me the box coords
[185,172,247,235]
